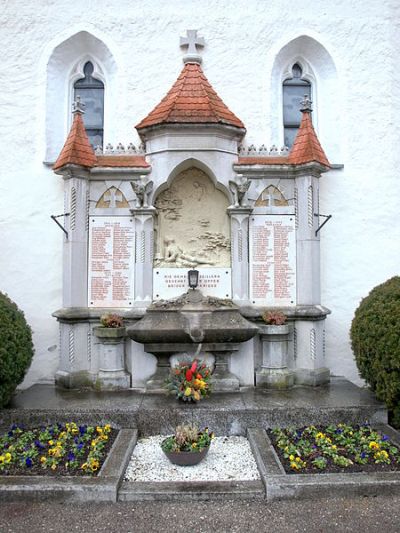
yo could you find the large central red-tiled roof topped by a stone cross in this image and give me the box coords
[136,63,244,130]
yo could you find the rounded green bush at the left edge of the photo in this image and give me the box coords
[0,292,33,407]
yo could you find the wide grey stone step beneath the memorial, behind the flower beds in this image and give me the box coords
[0,379,387,436]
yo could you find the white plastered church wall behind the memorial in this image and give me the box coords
[0,0,400,385]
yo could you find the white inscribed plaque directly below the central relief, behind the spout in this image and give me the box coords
[153,268,232,300]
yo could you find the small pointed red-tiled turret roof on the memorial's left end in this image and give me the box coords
[53,112,96,170]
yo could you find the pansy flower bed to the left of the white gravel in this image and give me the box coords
[0,422,118,476]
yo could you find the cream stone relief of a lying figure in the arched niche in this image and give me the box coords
[154,168,230,268]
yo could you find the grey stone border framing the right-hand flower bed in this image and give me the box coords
[248,424,400,501]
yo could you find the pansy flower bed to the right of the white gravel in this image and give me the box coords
[268,424,400,474]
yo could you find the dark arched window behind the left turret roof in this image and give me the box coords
[74,61,104,147]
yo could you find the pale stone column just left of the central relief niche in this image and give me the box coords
[131,207,157,307]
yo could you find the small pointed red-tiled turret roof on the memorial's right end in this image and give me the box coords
[289,111,330,167]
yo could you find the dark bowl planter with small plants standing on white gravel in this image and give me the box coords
[161,424,214,466]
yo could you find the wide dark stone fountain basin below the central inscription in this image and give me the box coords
[127,291,258,344]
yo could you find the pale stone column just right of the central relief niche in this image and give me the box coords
[227,206,253,305]
